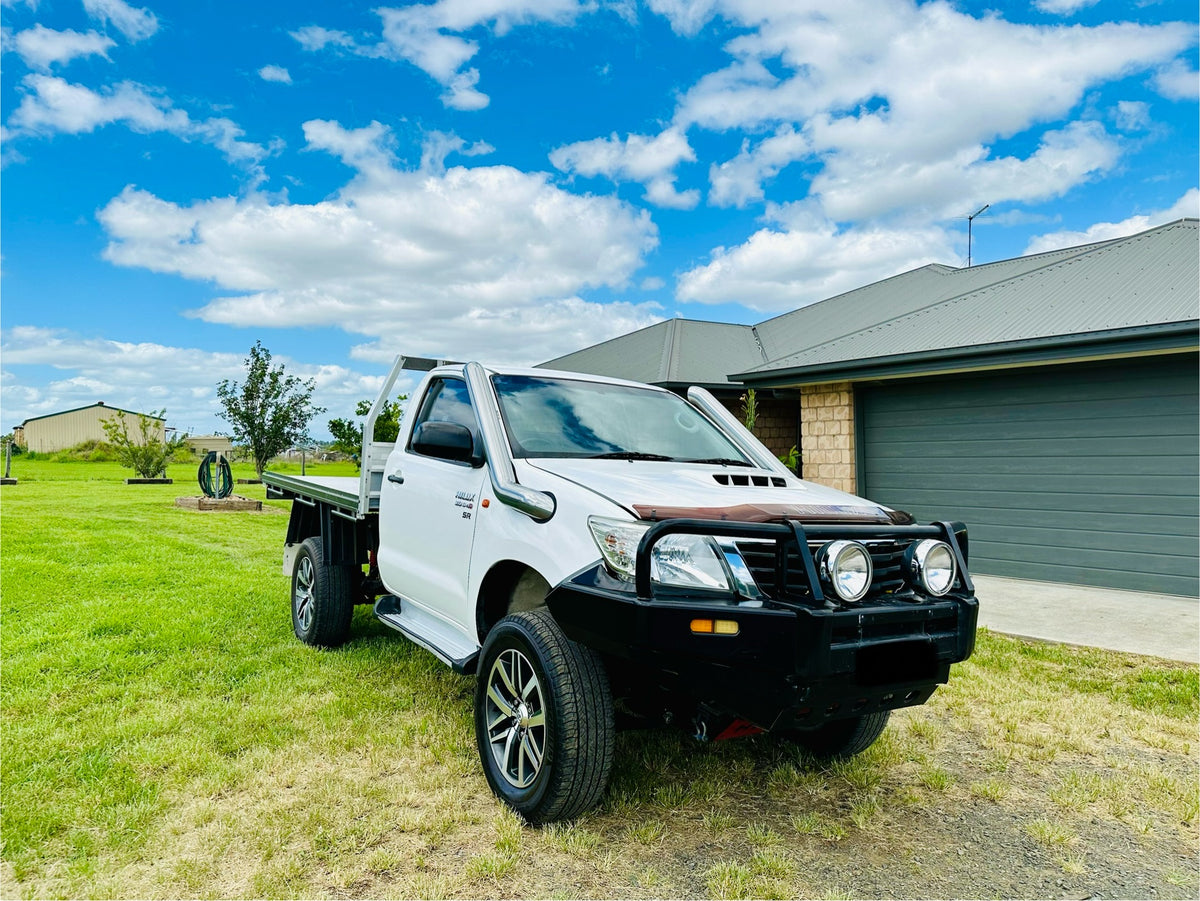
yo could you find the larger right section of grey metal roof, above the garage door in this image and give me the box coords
[734,220,1200,383]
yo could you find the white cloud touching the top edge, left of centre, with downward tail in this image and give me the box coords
[297,0,596,110]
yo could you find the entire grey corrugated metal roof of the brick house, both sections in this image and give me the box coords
[541,220,1200,388]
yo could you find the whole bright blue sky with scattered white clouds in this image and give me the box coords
[0,0,1200,434]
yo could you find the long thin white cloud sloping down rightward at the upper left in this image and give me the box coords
[8,74,268,175]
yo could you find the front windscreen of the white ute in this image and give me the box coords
[492,376,749,465]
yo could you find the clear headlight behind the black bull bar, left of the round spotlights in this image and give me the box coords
[588,516,731,591]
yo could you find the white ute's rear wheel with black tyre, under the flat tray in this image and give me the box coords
[292,537,361,648]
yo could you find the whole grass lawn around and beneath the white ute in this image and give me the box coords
[0,457,1200,897]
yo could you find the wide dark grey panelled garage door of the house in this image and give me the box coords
[856,354,1200,597]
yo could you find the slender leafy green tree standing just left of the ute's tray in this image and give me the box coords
[217,341,325,477]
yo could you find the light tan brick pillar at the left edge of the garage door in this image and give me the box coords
[800,382,857,494]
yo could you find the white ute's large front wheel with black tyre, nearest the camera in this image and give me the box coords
[475,609,614,825]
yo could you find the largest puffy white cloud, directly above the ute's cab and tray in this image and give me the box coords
[91,121,658,362]
